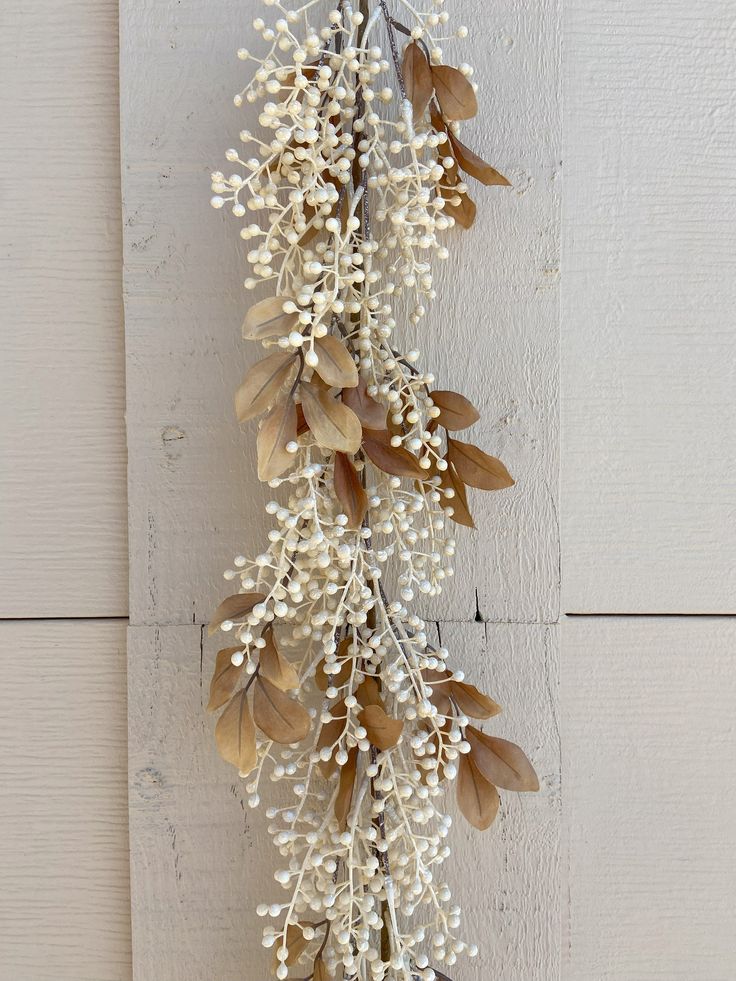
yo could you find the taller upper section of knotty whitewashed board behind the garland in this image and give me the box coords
[121,0,560,624]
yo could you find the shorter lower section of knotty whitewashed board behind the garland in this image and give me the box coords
[129,623,560,981]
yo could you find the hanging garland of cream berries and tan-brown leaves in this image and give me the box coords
[208,0,538,981]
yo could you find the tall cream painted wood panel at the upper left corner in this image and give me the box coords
[0,0,128,617]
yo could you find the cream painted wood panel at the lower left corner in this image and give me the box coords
[0,620,131,981]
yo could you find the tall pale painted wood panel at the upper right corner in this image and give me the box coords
[562,0,736,613]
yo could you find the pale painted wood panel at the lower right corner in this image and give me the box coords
[561,617,736,981]
